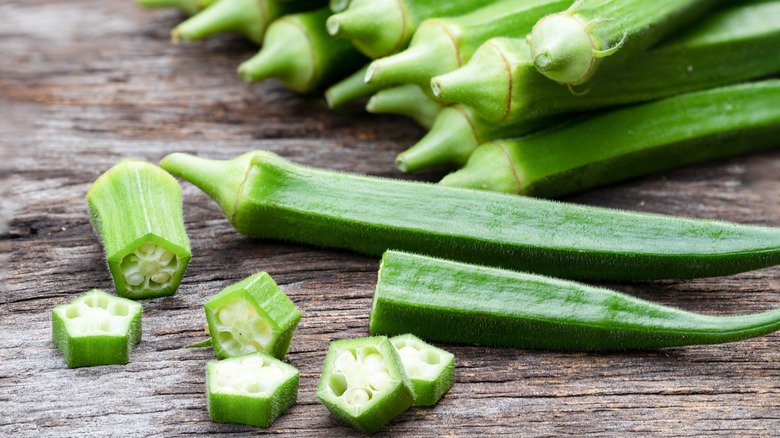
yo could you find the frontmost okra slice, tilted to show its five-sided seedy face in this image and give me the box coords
[317,336,414,434]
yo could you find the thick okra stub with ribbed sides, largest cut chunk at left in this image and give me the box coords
[87,159,192,299]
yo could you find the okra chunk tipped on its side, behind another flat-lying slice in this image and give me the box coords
[205,272,301,359]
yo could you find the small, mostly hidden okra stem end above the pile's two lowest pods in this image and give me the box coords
[366,84,441,129]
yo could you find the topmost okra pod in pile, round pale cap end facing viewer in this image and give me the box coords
[528,0,721,86]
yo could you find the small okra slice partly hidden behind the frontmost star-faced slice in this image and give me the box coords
[390,333,455,406]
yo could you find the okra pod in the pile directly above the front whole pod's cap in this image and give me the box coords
[238,8,366,93]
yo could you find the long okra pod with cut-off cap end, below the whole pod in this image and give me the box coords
[369,251,780,351]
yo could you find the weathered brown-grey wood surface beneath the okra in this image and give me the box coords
[0,0,780,436]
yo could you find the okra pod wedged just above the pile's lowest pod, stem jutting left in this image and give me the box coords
[395,105,570,172]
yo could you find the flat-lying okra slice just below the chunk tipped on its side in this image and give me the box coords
[206,351,299,427]
